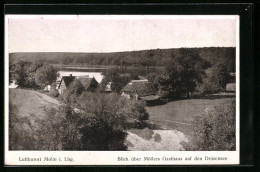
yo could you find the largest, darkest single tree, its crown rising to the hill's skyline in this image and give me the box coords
[148,48,210,100]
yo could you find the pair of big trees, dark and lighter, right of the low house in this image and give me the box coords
[144,48,234,102]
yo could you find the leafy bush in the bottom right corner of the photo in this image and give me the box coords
[193,101,236,151]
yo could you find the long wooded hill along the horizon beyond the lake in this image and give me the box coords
[9,47,236,72]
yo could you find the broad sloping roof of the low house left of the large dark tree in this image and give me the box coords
[121,82,156,97]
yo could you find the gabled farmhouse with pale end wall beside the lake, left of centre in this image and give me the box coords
[57,75,98,94]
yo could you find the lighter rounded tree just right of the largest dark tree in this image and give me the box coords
[197,63,230,94]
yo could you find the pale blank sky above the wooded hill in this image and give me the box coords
[7,15,236,52]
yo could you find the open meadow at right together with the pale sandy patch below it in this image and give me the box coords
[126,96,233,151]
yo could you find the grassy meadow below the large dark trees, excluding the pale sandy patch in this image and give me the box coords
[146,98,232,136]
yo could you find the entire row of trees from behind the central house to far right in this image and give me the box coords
[96,48,234,102]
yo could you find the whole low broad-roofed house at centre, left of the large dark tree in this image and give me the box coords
[121,80,160,104]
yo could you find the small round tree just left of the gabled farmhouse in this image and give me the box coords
[35,65,58,88]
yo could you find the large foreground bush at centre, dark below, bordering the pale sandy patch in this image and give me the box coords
[70,92,148,150]
